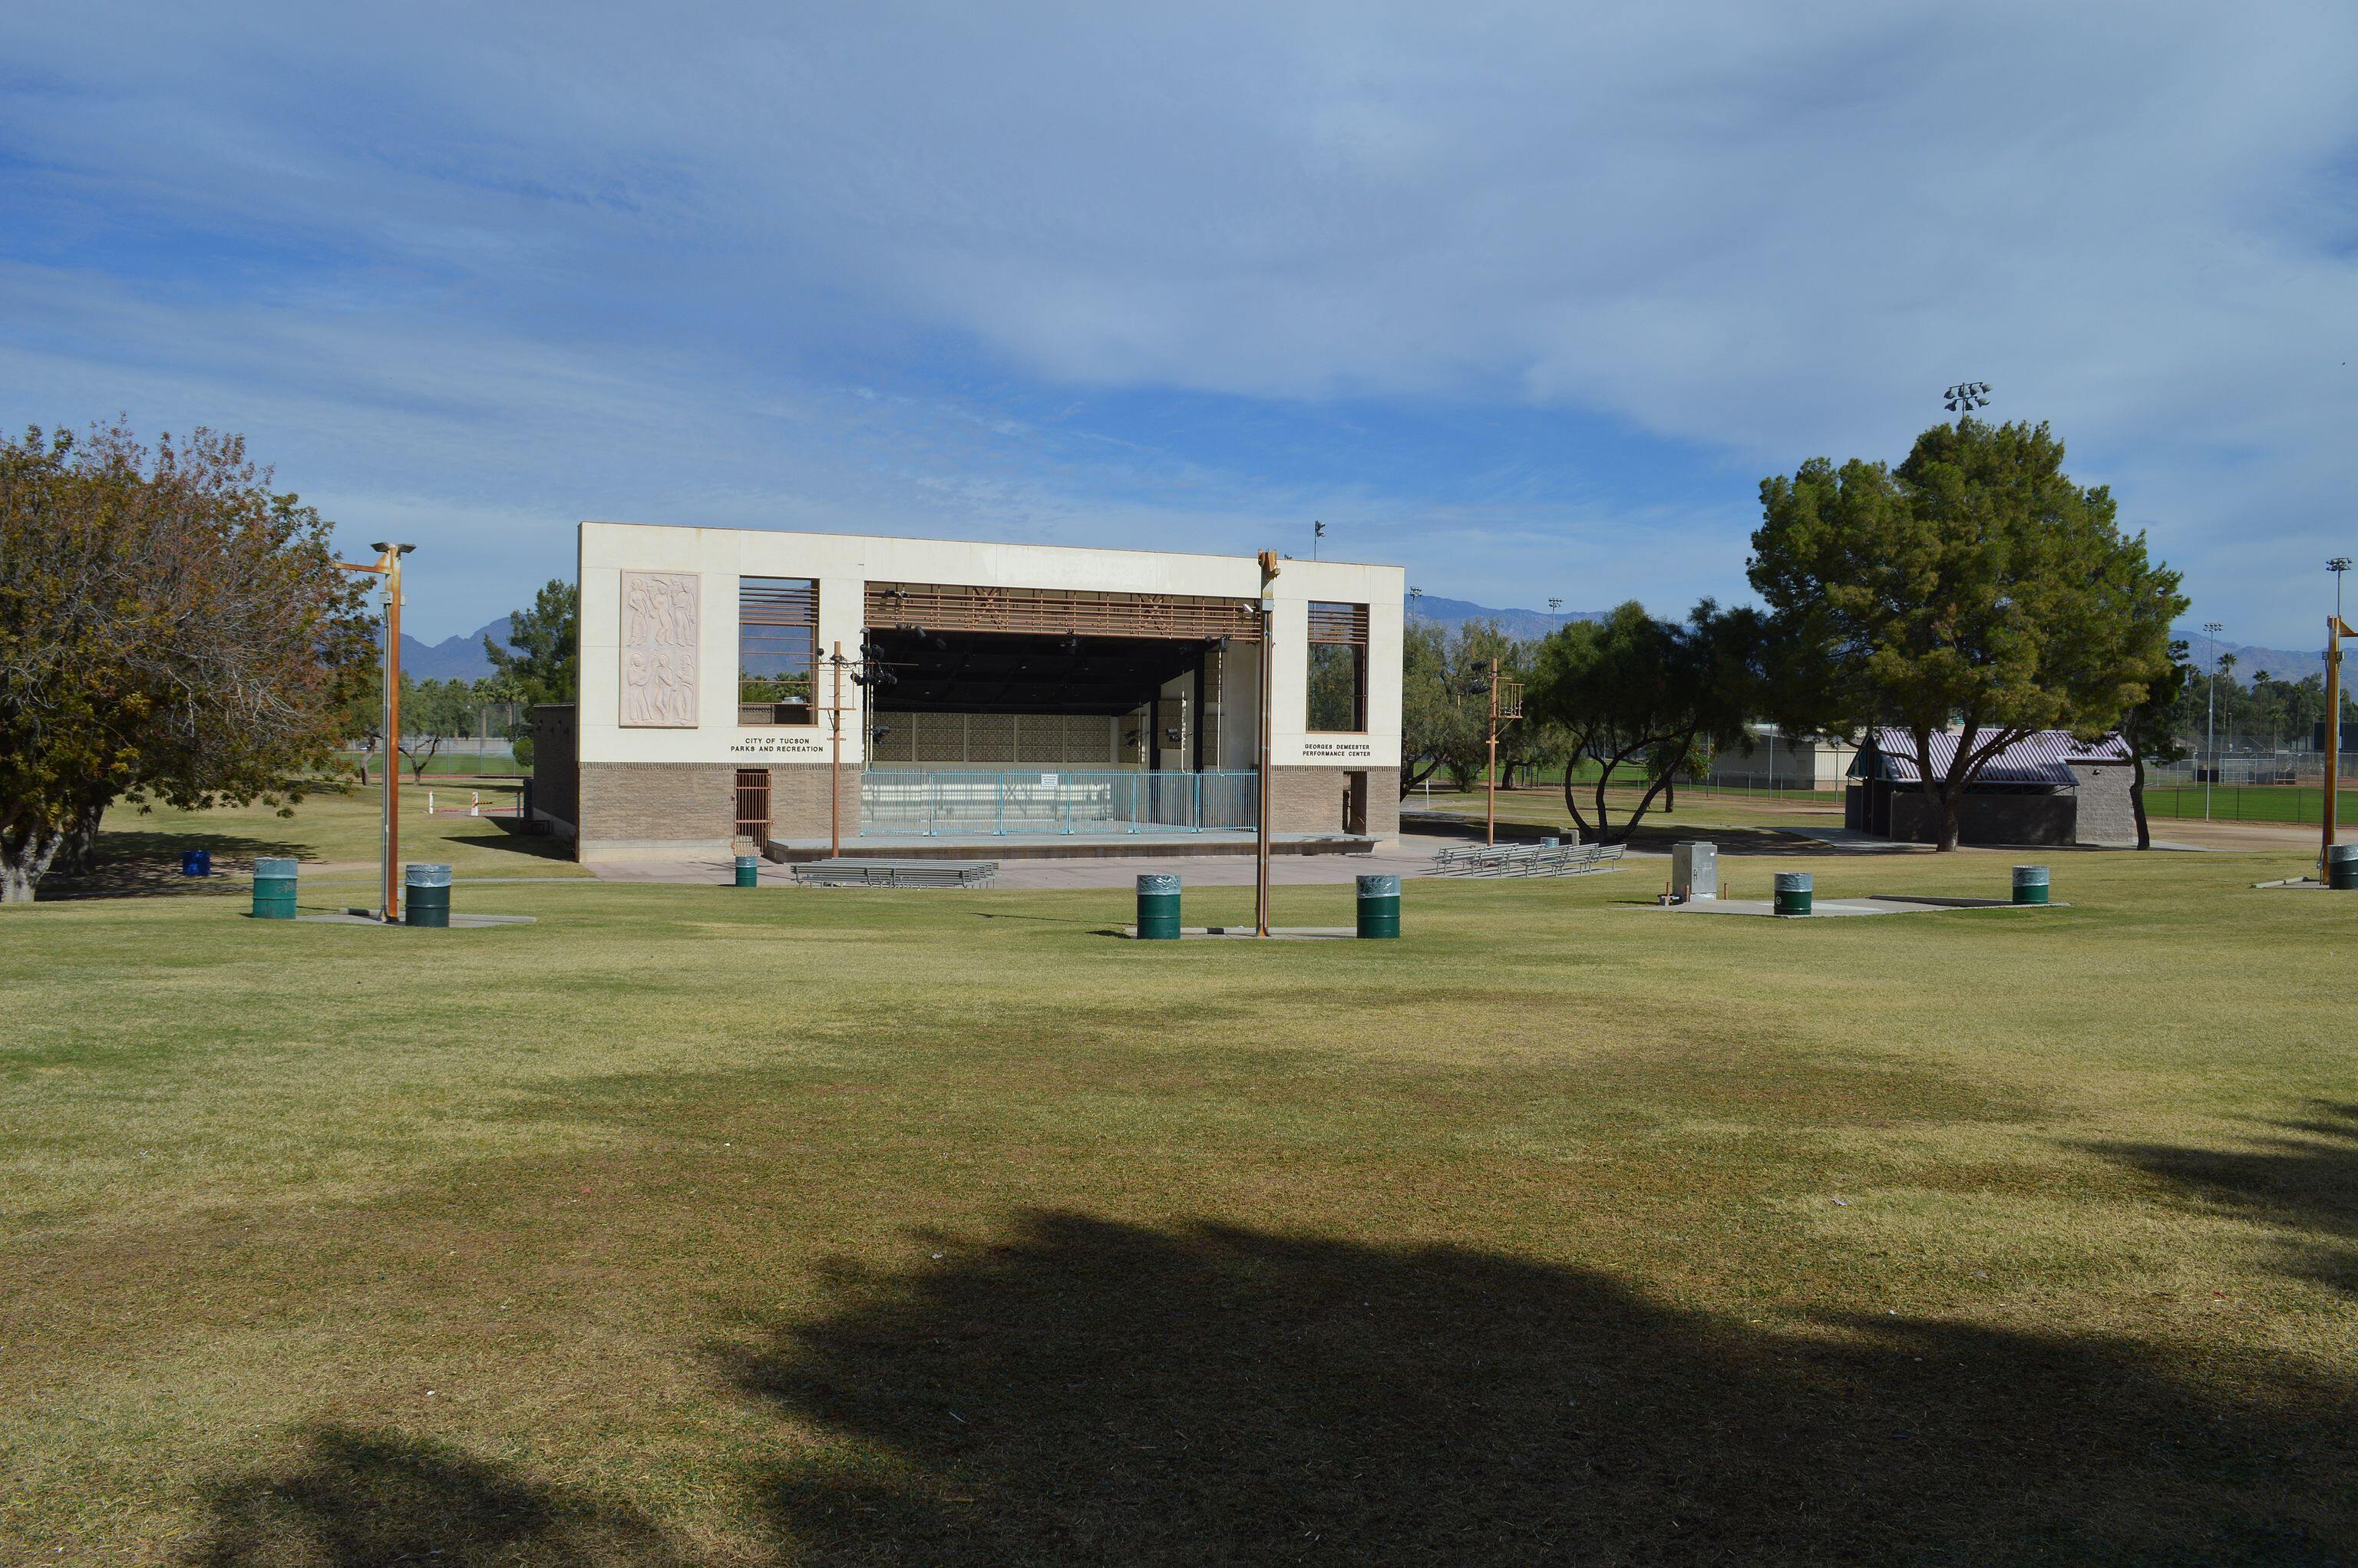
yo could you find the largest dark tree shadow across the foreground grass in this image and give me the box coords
[724,1214,2358,1563]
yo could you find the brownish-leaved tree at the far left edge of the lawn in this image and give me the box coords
[0,427,368,901]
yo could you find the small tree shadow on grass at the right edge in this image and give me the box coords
[2094,1101,2358,1295]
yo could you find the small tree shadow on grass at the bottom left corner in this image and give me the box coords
[189,1427,691,1568]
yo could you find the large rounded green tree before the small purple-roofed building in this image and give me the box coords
[1749,420,2186,849]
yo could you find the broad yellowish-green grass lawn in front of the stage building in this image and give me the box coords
[0,799,2358,1566]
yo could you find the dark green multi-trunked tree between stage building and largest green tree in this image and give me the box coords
[1524,599,1764,844]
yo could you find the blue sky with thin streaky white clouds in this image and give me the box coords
[0,0,2358,646]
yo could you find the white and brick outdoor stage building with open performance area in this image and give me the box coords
[533,523,1405,858]
